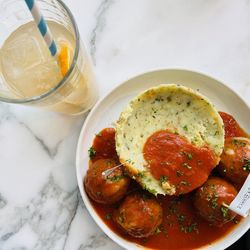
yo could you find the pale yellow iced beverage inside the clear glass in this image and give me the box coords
[0,21,97,114]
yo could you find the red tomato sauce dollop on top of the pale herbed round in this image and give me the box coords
[143,130,216,195]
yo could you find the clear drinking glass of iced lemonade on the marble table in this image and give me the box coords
[0,0,98,115]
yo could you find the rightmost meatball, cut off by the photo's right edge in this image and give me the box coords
[218,137,250,185]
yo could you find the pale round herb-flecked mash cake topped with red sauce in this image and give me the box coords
[116,84,224,195]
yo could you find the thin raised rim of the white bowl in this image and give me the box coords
[76,68,250,250]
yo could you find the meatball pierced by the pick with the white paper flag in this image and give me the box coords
[194,177,237,226]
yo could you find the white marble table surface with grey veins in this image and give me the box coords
[0,0,250,250]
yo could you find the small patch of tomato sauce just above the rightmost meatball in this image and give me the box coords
[219,112,248,138]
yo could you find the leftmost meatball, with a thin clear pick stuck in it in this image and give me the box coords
[84,159,130,204]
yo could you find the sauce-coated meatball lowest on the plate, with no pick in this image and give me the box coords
[113,193,163,238]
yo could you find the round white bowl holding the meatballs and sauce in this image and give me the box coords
[76,69,250,250]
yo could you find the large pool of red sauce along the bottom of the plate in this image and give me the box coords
[91,194,239,250]
